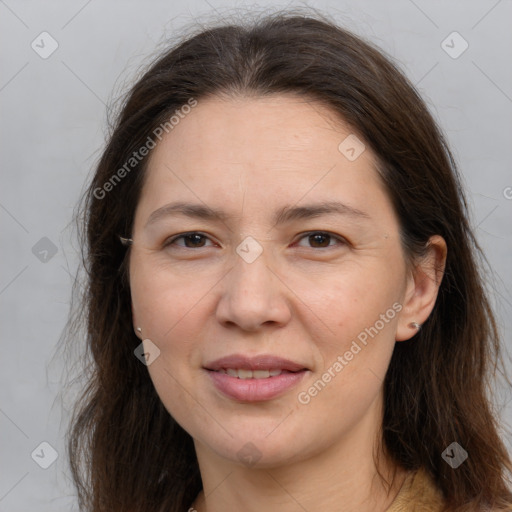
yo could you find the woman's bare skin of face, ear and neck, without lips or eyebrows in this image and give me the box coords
[130,95,446,512]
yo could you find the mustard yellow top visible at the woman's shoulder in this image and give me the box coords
[386,468,444,512]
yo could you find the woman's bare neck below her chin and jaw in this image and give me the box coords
[192,400,406,512]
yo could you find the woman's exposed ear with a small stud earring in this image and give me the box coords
[395,235,447,341]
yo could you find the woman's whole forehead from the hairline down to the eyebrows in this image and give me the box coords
[135,95,392,226]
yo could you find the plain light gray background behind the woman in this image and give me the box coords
[0,0,512,512]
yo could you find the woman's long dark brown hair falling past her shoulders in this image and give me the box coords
[67,10,512,512]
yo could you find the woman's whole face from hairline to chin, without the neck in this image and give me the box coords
[130,95,422,467]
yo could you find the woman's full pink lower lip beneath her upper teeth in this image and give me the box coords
[207,370,306,402]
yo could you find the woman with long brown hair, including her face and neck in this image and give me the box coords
[65,8,512,512]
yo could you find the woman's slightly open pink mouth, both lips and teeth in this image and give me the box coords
[204,354,309,402]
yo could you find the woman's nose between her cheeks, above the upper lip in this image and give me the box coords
[216,247,292,331]
